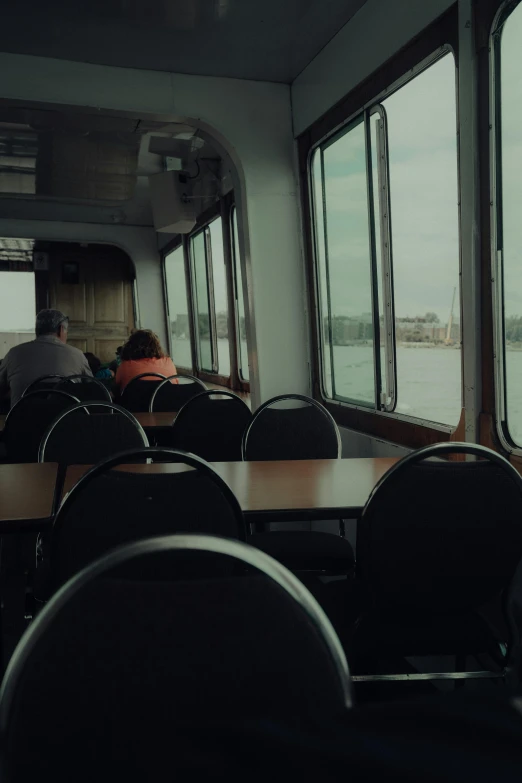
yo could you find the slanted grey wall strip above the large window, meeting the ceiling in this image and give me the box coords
[292,0,455,136]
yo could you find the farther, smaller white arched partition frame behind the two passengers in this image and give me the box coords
[0,218,162,345]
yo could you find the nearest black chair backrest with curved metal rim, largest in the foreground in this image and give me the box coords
[0,536,351,783]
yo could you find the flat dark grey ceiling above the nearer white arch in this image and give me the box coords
[0,0,366,83]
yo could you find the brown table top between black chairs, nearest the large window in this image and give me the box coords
[64,457,397,519]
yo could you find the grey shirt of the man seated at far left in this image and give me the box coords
[0,334,92,407]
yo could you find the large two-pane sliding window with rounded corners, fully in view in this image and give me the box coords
[311,54,462,426]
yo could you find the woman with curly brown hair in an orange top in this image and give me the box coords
[116,329,177,392]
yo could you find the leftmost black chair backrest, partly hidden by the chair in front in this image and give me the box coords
[4,388,79,462]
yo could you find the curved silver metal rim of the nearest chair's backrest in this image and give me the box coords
[0,534,352,741]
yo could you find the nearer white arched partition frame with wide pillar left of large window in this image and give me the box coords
[0,53,310,405]
